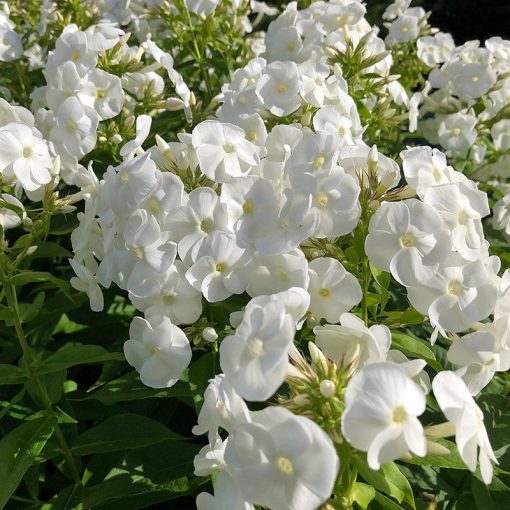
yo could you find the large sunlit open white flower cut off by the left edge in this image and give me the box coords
[0,122,53,191]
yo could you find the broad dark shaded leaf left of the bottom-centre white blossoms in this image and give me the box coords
[73,414,184,455]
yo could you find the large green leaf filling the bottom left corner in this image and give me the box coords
[0,418,53,508]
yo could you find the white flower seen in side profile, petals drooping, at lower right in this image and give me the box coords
[432,371,498,484]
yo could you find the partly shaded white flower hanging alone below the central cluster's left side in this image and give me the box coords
[124,315,191,388]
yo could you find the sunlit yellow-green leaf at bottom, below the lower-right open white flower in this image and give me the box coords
[353,455,416,508]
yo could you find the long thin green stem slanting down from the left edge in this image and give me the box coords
[0,261,81,484]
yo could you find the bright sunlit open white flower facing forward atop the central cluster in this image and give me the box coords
[191,120,259,182]
